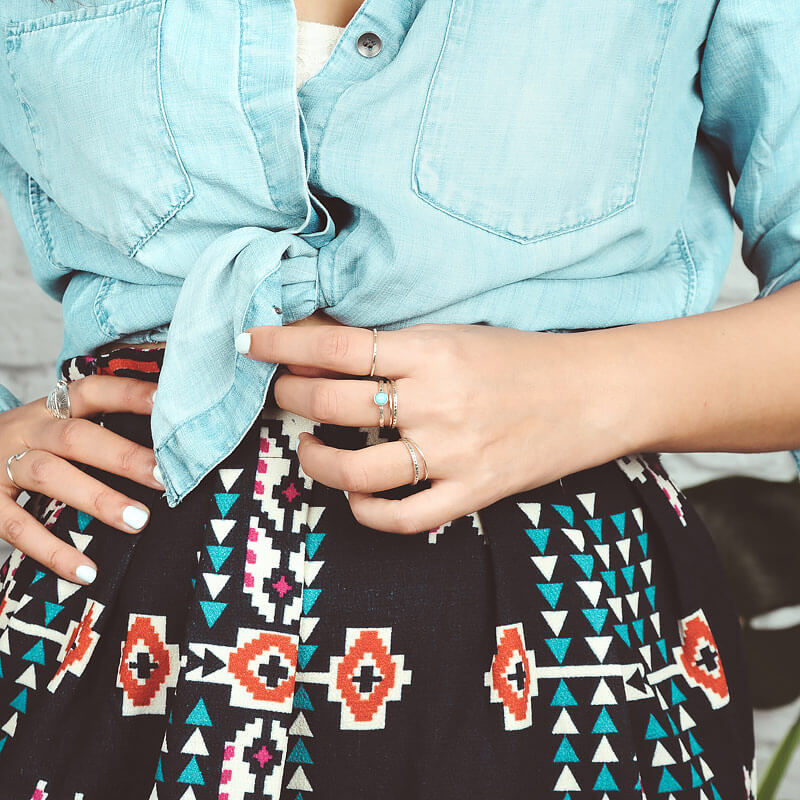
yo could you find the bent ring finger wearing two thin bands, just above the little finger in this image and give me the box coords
[297,433,422,492]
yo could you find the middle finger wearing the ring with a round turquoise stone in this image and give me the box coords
[275,373,415,427]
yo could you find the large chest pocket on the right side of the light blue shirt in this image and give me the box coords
[412,0,677,243]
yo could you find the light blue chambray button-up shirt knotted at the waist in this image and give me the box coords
[0,0,800,505]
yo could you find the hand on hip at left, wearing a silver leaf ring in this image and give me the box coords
[0,375,164,584]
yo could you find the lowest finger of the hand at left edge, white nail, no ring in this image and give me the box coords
[0,494,97,585]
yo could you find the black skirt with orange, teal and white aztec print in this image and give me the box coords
[0,349,754,800]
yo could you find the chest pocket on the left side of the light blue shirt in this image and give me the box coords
[6,0,192,256]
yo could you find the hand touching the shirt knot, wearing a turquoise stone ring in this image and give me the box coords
[237,324,635,533]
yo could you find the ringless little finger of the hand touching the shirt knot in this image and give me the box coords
[348,480,466,533]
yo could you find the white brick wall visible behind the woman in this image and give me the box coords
[0,192,800,788]
